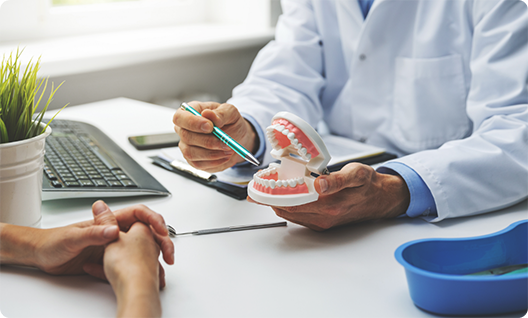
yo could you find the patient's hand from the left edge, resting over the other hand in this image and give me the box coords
[28,201,174,287]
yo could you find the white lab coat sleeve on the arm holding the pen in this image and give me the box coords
[227,0,325,165]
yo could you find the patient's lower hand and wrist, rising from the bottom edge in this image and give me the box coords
[104,222,161,318]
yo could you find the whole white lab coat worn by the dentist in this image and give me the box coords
[229,0,528,221]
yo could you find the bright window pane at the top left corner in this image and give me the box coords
[0,0,207,43]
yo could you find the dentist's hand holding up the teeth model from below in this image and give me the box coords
[248,163,410,231]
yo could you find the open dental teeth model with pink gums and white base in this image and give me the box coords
[248,112,331,206]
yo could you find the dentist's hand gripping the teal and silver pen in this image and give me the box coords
[173,102,258,172]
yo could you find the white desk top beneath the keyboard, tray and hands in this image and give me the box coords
[0,99,528,318]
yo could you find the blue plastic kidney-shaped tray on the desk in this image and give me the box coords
[395,220,528,315]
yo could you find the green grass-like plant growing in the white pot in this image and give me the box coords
[0,49,67,144]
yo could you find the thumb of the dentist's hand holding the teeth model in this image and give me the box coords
[314,163,374,195]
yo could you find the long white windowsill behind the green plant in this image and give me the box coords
[0,24,274,77]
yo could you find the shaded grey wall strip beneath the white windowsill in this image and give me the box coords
[44,46,260,109]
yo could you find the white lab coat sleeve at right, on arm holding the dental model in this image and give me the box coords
[397,0,528,221]
